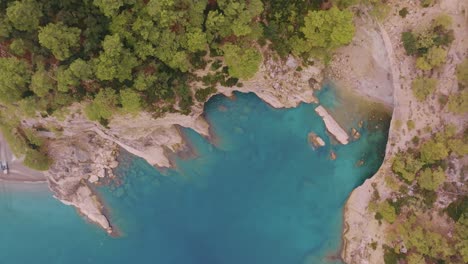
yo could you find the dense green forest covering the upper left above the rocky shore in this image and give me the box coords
[0,0,354,169]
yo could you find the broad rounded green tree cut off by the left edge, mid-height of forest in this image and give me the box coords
[0,58,31,103]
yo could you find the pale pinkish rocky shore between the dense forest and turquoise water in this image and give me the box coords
[24,52,323,232]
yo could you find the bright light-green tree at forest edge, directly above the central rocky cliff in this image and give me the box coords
[222,44,262,79]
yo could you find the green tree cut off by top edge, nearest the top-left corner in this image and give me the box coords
[6,0,42,31]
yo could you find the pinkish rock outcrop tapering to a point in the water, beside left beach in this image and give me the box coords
[46,131,117,233]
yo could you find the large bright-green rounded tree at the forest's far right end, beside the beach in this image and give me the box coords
[301,7,355,50]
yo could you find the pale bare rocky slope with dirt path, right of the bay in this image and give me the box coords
[336,0,468,264]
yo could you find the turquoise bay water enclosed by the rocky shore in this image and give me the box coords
[0,89,386,264]
